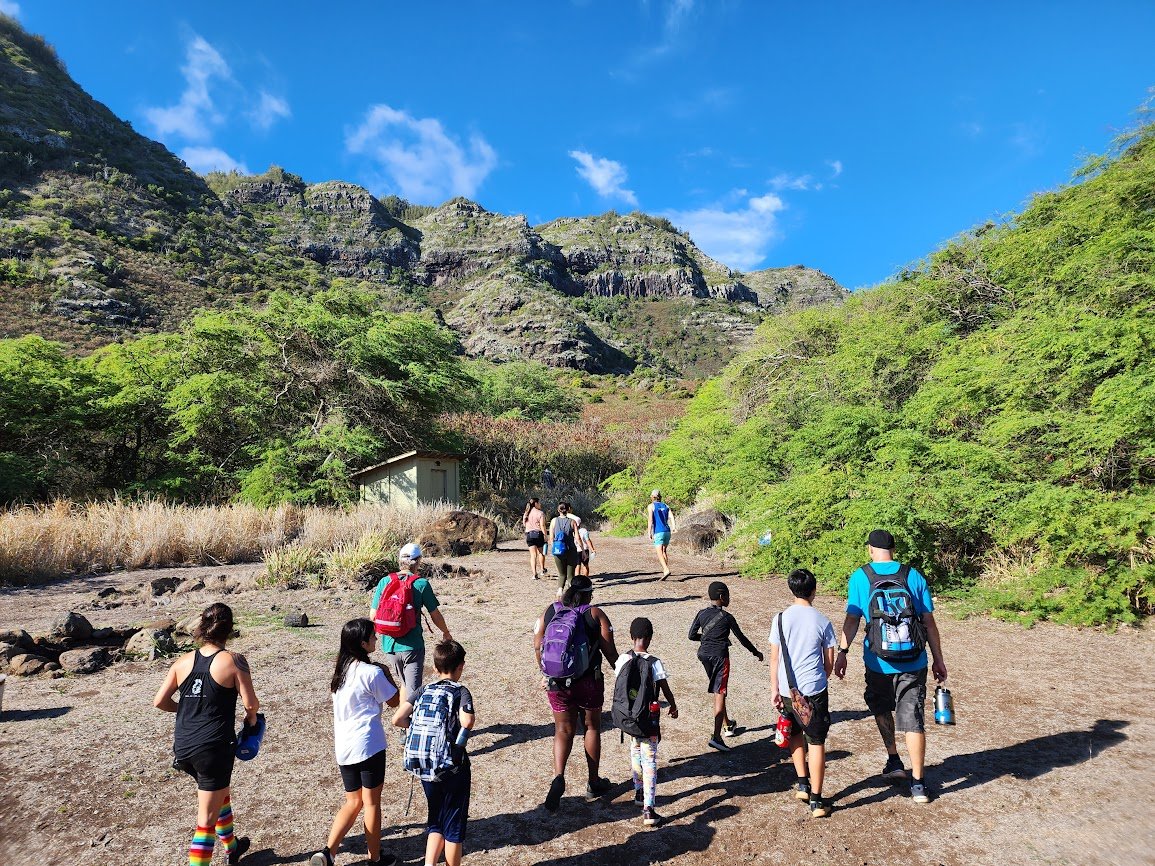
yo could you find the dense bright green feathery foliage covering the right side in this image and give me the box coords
[606,125,1155,624]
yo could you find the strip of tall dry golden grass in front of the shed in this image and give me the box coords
[0,501,468,583]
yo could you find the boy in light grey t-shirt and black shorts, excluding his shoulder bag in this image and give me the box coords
[770,568,837,818]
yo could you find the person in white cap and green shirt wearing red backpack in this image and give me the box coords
[368,543,453,700]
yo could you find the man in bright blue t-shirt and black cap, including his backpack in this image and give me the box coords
[834,529,947,802]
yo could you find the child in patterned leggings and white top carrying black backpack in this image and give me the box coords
[613,617,678,827]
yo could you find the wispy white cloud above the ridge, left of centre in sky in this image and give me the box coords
[345,105,498,203]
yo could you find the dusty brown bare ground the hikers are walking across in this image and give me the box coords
[0,538,1155,866]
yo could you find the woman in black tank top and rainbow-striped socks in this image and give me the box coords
[152,603,260,866]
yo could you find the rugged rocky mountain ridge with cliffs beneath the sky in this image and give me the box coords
[0,16,844,375]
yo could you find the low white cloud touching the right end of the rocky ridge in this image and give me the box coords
[662,193,785,270]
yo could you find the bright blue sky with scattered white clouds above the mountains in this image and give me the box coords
[9,0,1155,288]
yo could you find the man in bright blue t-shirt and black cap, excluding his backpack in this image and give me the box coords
[834,529,946,802]
